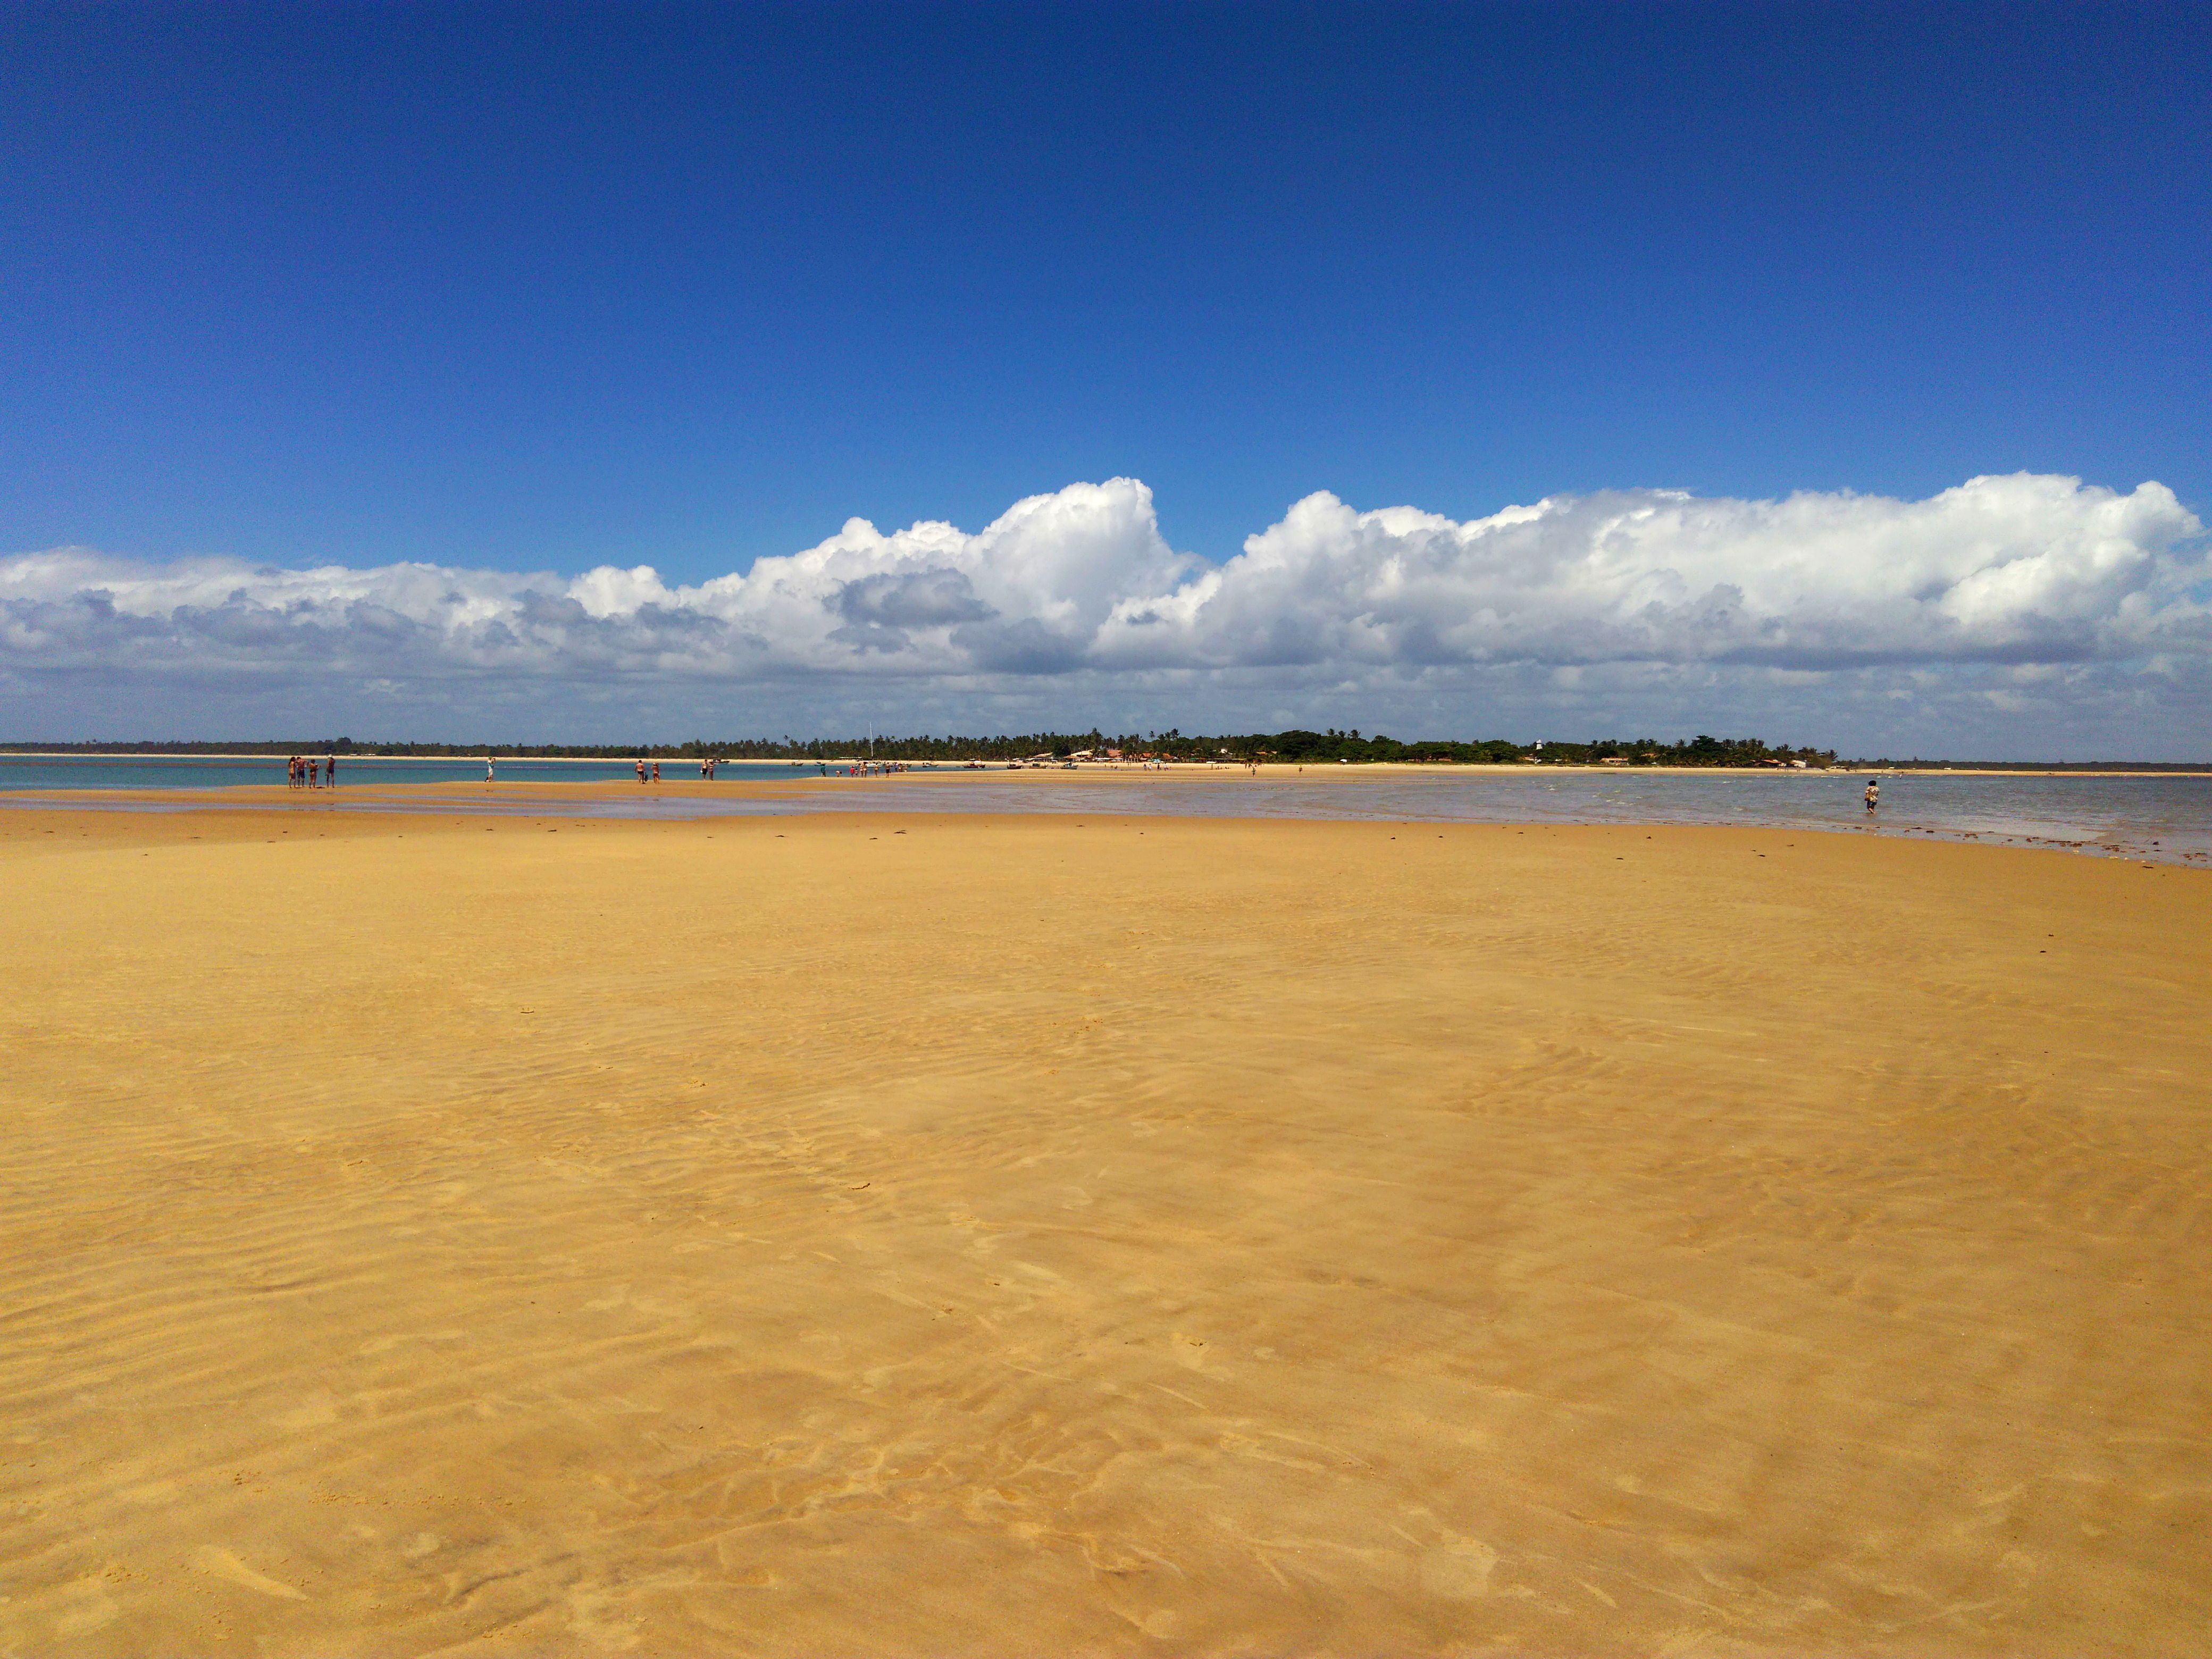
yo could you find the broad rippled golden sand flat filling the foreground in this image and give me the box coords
[0,812,2212,1655]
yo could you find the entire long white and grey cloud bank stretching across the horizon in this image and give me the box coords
[0,473,2212,752]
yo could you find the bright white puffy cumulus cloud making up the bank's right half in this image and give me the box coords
[1100,475,2206,668]
